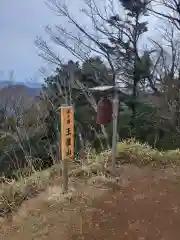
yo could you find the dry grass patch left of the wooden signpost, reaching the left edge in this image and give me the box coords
[0,165,60,217]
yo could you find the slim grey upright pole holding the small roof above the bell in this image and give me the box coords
[112,88,119,174]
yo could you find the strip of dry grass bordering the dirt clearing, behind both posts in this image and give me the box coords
[0,139,180,217]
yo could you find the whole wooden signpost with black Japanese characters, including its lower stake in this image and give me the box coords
[60,105,74,192]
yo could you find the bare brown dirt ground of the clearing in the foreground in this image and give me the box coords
[0,166,180,240]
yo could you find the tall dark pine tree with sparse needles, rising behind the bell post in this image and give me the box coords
[108,0,151,129]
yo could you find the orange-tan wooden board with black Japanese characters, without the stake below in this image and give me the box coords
[60,106,74,160]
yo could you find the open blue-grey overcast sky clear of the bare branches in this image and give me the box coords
[0,0,162,84]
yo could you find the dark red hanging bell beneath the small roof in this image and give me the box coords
[96,97,113,125]
